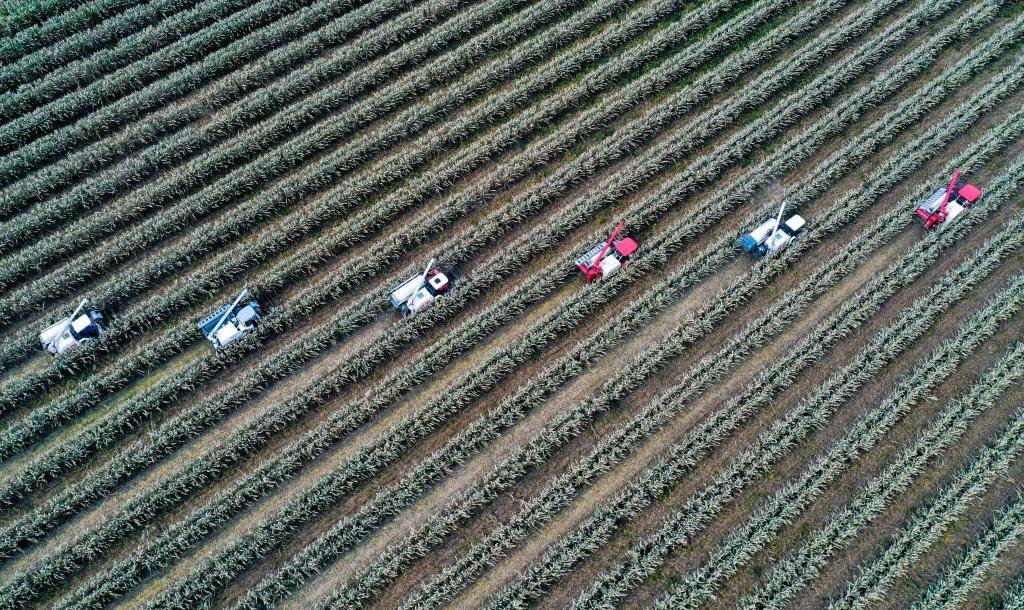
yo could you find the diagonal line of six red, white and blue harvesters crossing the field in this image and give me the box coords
[39,169,981,355]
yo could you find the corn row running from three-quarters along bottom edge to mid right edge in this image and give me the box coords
[740,343,1024,610]
